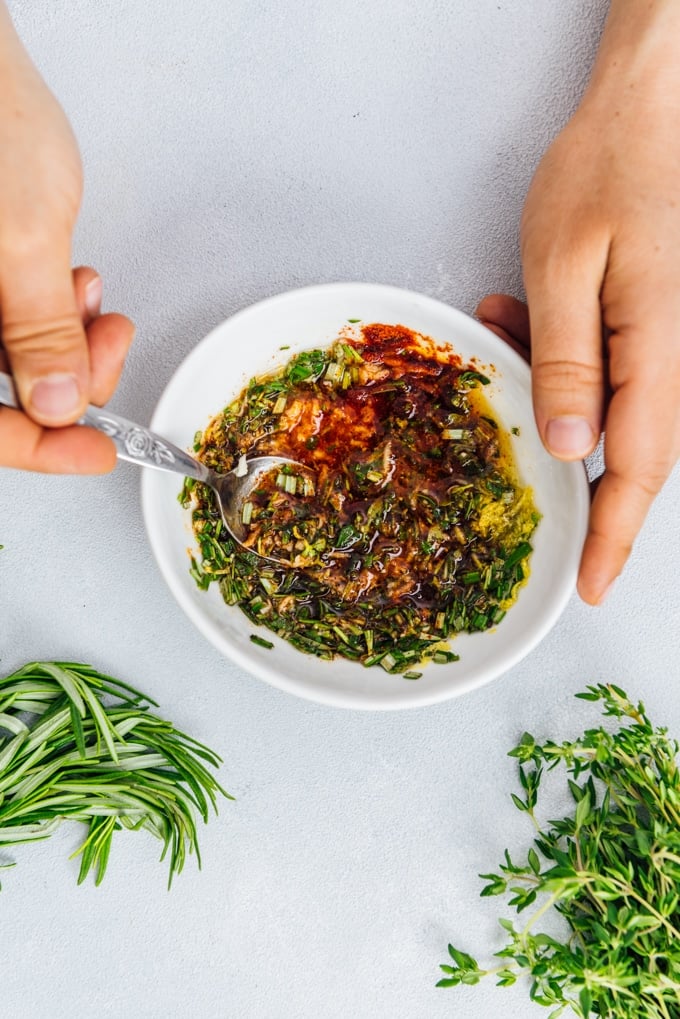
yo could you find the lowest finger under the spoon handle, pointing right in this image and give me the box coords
[0,407,116,474]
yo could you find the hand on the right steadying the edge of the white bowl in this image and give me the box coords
[499,0,680,604]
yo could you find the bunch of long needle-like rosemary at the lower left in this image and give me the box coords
[0,661,232,887]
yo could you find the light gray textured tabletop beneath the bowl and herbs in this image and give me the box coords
[0,0,680,1019]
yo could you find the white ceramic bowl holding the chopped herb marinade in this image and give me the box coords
[142,283,588,709]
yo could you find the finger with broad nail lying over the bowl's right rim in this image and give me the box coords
[523,238,608,460]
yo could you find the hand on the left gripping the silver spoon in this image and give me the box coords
[0,3,134,473]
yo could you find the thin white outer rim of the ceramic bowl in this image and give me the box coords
[141,281,589,710]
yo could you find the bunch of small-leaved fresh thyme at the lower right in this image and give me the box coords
[437,684,680,1019]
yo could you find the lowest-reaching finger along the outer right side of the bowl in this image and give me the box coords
[577,370,678,604]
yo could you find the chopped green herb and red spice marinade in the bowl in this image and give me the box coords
[181,324,539,679]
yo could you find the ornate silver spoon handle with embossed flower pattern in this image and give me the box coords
[0,372,209,481]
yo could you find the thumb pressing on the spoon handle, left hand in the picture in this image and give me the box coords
[0,240,90,427]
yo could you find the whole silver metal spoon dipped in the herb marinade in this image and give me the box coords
[0,372,313,566]
